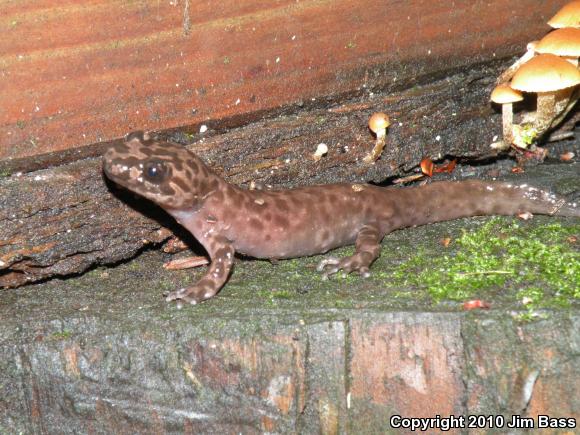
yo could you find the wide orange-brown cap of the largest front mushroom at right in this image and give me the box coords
[511,54,580,92]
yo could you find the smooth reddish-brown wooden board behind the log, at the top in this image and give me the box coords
[0,0,563,164]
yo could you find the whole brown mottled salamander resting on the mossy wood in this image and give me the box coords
[103,132,580,304]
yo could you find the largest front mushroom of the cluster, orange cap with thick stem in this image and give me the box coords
[511,54,580,134]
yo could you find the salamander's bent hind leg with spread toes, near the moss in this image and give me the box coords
[316,226,381,279]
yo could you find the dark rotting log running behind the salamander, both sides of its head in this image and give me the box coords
[0,65,508,287]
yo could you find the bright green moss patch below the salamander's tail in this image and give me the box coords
[391,218,580,313]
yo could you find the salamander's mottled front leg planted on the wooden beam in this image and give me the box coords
[165,236,234,307]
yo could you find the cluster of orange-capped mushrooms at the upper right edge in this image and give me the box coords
[490,0,580,152]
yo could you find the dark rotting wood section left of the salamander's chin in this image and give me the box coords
[0,159,168,286]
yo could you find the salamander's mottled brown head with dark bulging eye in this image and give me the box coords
[103,132,219,209]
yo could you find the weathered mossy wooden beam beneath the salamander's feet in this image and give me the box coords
[0,258,580,435]
